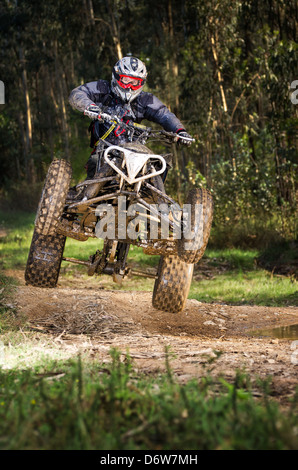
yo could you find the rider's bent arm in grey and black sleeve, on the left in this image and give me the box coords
[69,80,109,112]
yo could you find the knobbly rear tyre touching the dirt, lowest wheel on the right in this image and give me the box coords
[152,255,193,312]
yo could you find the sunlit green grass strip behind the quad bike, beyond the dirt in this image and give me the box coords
[0,212,298,306]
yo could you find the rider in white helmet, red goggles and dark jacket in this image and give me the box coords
[69,57,191,179]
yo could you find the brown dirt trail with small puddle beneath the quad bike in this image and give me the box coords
[8,271,298,401]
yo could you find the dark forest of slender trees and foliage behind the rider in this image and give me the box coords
[0,0,298,247]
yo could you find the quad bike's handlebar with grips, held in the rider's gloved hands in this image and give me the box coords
[84,110,195,142]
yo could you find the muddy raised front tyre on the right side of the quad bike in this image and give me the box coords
[177,188,213,264]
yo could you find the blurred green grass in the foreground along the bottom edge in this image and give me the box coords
[0,349,298,451]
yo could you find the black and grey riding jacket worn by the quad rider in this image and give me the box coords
[69,80,185,143]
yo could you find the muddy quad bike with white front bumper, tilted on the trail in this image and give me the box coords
[25,112,213,312]
